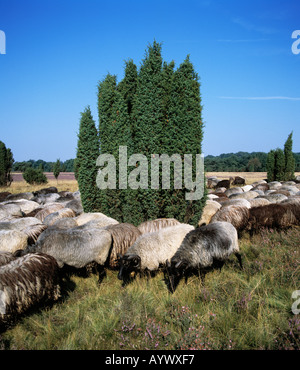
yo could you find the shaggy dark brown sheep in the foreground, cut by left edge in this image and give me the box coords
[0,253,60,325]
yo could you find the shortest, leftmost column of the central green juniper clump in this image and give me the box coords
[76,106,99,212]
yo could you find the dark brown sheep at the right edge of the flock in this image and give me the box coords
[247,203,300,232]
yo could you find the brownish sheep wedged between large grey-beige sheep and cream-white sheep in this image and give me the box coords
[105,223,142,269]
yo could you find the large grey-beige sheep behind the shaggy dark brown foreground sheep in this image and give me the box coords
[19,227,112,282]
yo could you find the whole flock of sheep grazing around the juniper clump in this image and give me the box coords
[0,178,300,326]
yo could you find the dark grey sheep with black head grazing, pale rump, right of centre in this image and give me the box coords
[165,222,243,293]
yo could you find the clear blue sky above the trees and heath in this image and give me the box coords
[0,0,300,161]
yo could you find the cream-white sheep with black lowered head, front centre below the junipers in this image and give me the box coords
[118,224,194,283]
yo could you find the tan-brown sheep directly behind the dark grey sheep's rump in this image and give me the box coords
[210,205,249,232]
